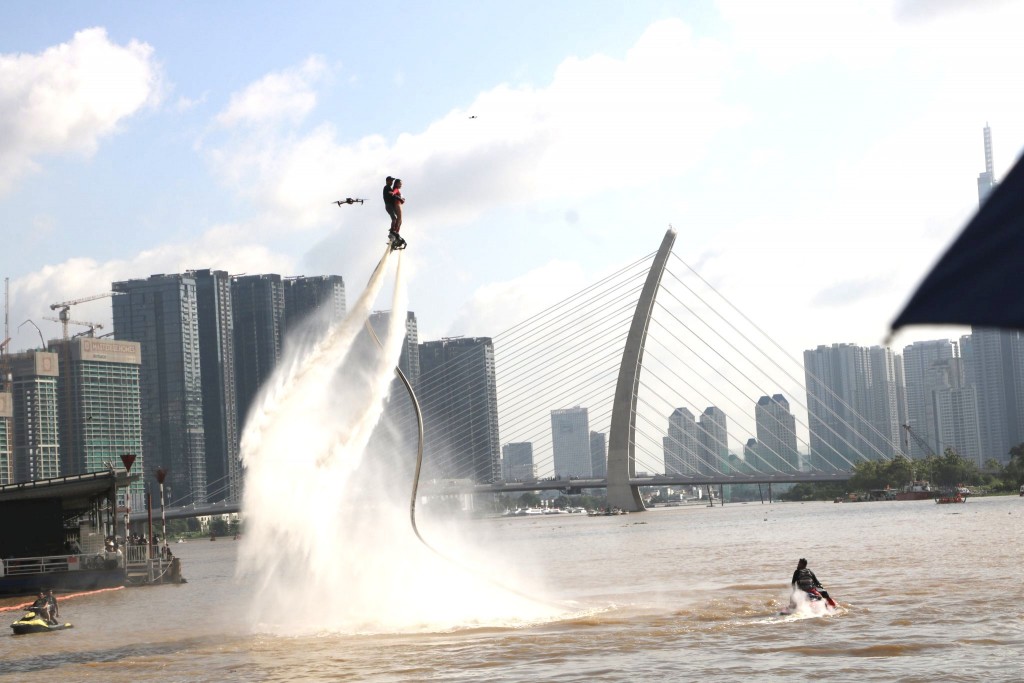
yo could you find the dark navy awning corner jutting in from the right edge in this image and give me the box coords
[892,155,1024,331]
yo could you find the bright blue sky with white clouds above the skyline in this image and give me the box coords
[0,0,1024,378]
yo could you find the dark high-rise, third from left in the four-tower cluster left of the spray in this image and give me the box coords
[231,274,285,429]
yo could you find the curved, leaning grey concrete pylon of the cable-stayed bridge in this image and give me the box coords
[607,227,676,512]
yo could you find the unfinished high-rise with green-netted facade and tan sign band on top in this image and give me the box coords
[49,337,145,510]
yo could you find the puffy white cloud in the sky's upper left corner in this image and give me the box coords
[0,28,160,195]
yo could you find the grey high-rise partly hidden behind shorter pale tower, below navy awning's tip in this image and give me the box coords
[903,339,953,458]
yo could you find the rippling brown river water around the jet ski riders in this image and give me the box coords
[0,497,1024,682]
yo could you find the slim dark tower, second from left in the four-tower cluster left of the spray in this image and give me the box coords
[187,269,243,503]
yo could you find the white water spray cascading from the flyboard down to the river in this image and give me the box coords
[239,252,561,633]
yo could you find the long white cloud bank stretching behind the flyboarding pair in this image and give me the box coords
[201,19,740,237]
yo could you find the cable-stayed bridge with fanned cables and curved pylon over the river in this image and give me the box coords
[155,229,902,516]
